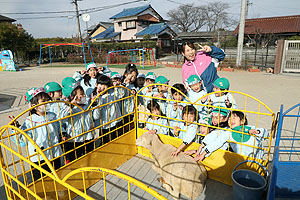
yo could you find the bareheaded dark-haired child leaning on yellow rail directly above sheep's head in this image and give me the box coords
[144,99,168,135]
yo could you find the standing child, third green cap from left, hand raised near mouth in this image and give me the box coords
[62,79,100,163]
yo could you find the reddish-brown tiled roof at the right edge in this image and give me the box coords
[234,15,300,34]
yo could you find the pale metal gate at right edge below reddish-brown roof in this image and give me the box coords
[281,40,300,73]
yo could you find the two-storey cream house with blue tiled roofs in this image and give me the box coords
[92,5,176,52]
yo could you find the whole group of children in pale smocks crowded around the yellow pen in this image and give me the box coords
[11,63,267,179]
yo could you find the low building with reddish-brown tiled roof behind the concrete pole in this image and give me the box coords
[234,15,300,45]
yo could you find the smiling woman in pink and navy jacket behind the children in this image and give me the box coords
[182,42,225,93]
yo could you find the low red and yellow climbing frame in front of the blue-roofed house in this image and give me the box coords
[106,48,156,69]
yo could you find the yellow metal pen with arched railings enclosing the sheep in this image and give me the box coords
[0,84,275,199]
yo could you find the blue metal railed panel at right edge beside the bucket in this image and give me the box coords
[267,104,300,200]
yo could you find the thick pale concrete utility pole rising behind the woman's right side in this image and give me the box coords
[236,0,247,67]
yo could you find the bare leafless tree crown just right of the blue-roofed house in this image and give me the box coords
[167,4,206,32]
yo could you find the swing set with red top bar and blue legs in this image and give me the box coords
[39,43,94,67]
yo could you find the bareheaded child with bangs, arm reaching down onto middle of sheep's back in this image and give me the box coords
[171,105,198,156]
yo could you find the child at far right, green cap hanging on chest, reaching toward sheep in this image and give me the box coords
[194,111,268,161]
